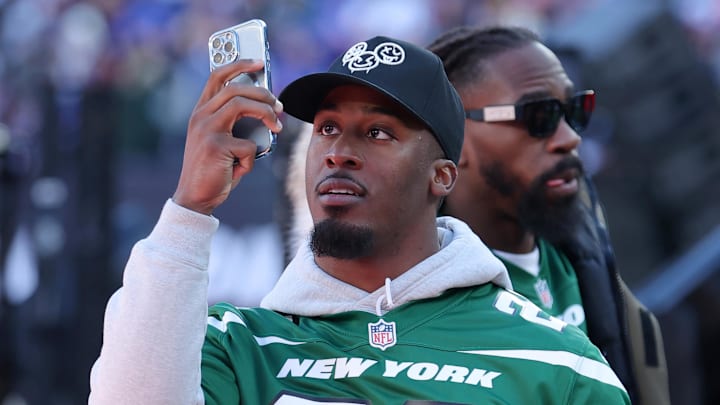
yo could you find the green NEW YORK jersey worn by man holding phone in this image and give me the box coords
[202,284,629,405]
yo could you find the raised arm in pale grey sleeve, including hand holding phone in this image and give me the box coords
[89,60,282,404]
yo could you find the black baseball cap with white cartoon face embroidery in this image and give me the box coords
[279,36,465,164]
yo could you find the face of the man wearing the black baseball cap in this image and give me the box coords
[306,85,440,259]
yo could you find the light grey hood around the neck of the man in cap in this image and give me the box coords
[260,217,512,316]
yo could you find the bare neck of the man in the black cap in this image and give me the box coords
[315,221,440,292]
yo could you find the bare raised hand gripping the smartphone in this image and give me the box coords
[173,60,282,215]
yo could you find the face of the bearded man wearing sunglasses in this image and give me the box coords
[456,43,582,231]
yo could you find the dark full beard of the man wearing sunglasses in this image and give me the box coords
[518,157,584,244]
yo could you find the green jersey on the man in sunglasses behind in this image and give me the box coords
[499,239,587,333]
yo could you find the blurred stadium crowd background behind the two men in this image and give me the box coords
[0,0,720,405]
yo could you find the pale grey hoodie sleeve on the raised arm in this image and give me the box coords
[88,200,219,405]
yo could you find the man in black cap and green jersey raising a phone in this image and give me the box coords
[89,37,629,404]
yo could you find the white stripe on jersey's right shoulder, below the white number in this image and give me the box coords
[461,350,625,391]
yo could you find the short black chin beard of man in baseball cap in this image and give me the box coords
[310,219,374,260]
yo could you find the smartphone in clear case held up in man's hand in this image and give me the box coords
[208,19,277,159]
